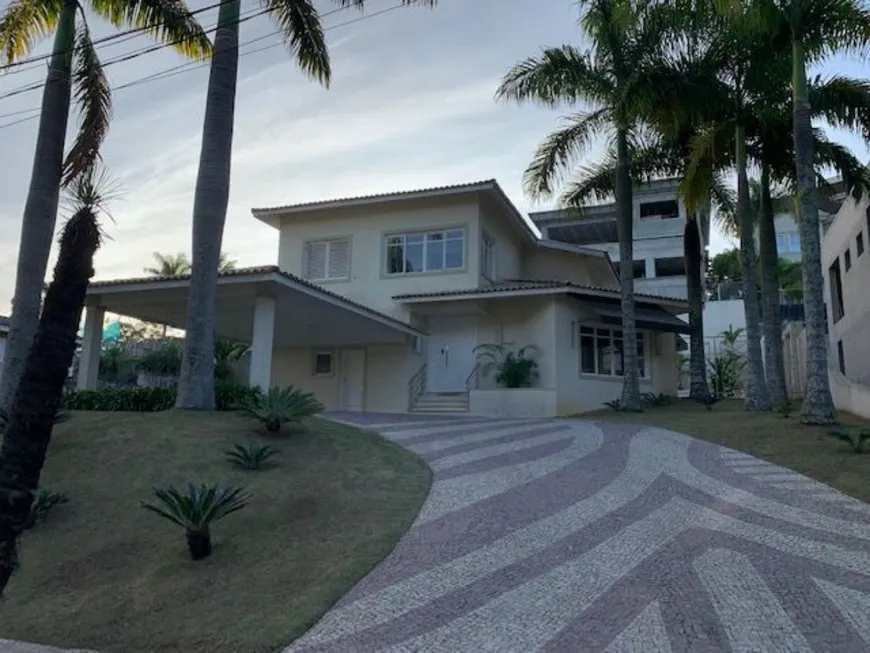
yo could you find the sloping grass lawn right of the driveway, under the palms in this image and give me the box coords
[582,400,870,502]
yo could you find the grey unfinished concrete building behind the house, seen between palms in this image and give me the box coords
[530,179,709,299]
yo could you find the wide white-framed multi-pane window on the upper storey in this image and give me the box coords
[386,229,465,274]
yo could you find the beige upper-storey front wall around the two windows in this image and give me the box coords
[278,198,480,320]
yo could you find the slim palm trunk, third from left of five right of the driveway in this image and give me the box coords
[734,125,770,410]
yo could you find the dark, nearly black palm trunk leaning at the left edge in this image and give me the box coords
[0,209,100,594]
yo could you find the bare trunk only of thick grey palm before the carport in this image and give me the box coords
[176,0,240,410]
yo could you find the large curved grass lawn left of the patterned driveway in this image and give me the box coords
[0,411,431,653]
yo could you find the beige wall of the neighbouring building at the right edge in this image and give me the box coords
[822,198,870,385]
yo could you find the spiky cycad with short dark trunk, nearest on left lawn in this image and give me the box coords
[142,483,250,560]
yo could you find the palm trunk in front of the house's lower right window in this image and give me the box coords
[615,127,642,412]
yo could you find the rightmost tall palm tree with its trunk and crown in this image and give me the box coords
[759,0,870,424]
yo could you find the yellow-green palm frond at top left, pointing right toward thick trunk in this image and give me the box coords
[92,0,212,59]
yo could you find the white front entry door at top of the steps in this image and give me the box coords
[426,317,477,392]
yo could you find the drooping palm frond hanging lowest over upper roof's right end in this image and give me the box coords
[523,109,610,199]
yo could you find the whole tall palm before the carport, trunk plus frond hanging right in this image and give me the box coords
[176,0,436,410]
